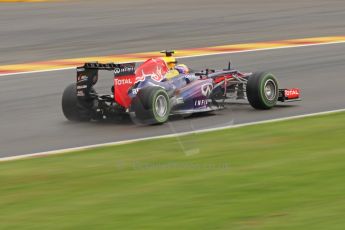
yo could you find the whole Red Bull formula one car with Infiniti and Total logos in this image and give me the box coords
[62,51,300,124]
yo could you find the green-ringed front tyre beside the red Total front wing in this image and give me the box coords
[247,72,278,109]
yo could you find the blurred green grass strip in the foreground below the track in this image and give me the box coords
[0,113,345,230]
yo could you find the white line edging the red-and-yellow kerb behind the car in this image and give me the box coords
[0,41,345,77]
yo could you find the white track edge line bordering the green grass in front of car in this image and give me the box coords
[0,109,345,162]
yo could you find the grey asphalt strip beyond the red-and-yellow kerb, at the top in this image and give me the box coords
[0,0,345,65]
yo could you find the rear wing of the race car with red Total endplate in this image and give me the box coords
[76,62,135,107]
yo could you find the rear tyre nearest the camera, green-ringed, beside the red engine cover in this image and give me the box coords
[131,87,171,124]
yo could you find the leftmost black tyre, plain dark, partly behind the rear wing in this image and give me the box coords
[62,83,93,121]
